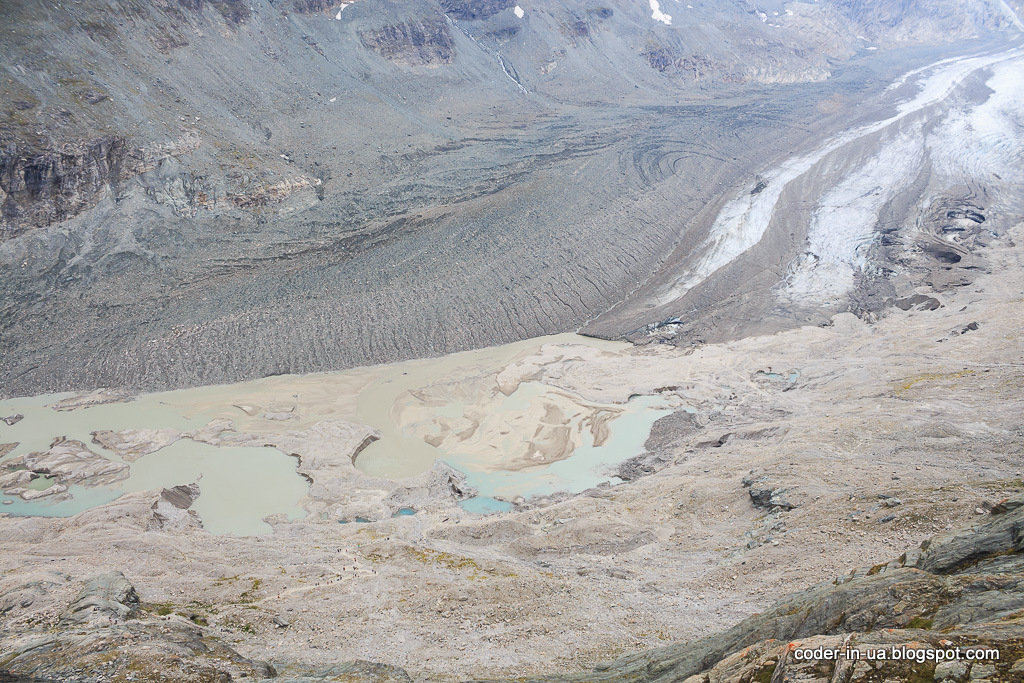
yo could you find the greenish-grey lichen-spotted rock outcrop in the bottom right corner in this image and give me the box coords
[499,495,1024,683]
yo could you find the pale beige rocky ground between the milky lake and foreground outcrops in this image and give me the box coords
[0,215,1024,683]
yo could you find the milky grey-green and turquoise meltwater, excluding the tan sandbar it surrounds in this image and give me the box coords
[0,334,666,536]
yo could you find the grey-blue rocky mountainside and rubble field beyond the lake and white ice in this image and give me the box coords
[0,0,1014,395]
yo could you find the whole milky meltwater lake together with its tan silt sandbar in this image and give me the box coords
[0,334,677,536]
